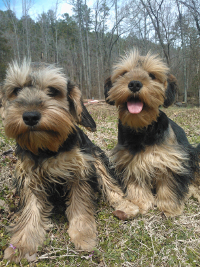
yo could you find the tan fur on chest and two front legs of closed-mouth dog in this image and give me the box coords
[5,148,96,261]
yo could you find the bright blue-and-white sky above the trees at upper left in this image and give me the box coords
[0,0,72,19]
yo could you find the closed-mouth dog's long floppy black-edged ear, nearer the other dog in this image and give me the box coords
[67,81,96,132]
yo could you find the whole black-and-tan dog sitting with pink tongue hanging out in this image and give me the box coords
[105,50,200,216]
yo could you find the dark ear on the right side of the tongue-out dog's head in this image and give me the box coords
[163,74,178,108]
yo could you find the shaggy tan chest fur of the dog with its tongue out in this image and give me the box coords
[113,142,186,186]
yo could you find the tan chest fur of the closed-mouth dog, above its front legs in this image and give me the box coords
[17,149,93,183]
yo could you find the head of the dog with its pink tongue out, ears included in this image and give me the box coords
[105,51,176,129]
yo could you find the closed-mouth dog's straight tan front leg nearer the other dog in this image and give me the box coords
[66,181,96,251]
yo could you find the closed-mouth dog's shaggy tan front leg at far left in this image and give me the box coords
[4,185,52,262]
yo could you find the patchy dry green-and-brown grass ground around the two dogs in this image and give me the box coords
[0,104,200,267]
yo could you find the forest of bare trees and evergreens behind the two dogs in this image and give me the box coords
[0,0,200,104]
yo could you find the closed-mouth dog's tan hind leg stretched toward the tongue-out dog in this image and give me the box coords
[95,160,139,220]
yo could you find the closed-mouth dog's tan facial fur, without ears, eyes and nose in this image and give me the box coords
[3,61,74,154]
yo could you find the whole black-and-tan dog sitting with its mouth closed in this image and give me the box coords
[2,60,138,262]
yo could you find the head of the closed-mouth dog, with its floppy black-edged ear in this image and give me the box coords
[2,60,96,154]
